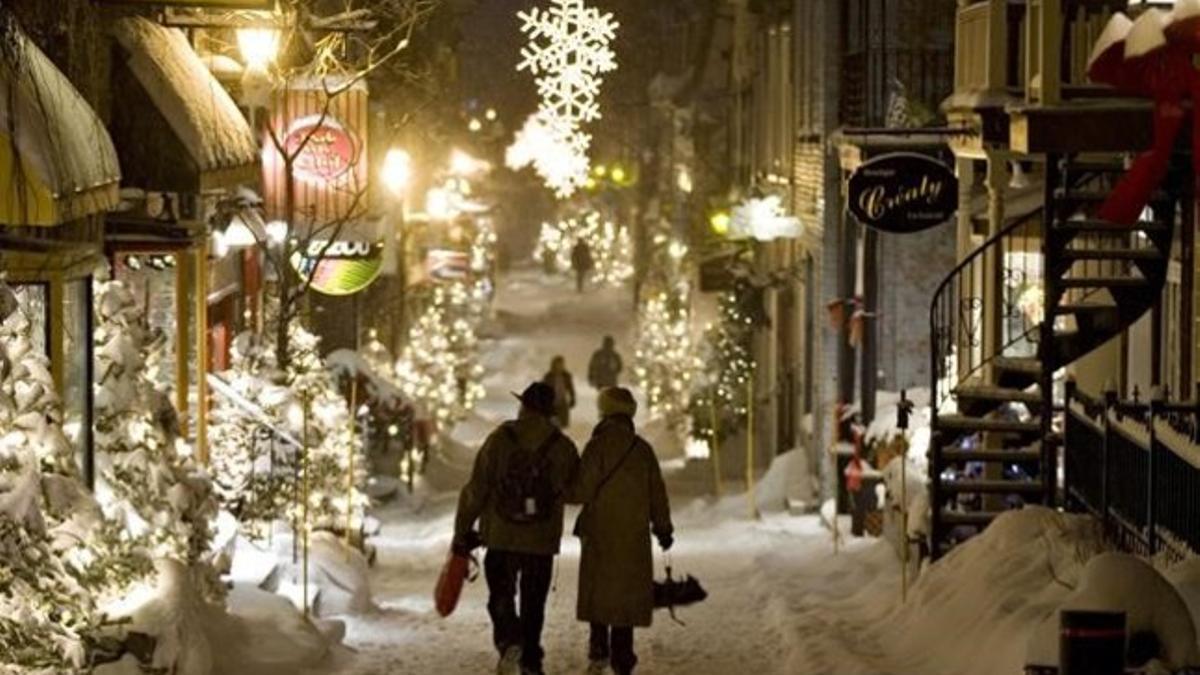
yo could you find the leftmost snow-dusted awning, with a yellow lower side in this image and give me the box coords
[0,23,121,226]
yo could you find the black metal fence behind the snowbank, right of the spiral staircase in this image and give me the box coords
[1063,382,1200,560]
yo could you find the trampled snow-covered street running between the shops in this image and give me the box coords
[319,273,898,675]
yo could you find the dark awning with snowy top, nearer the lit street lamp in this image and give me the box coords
[113,17,259,192]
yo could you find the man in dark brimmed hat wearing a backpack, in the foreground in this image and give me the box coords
[454,382,580,675]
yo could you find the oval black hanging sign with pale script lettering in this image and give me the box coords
[848,153,959,234]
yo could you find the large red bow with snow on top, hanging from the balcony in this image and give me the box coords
[1087,5,1200,225]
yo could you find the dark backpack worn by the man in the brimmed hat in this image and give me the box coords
[496,425,560,525]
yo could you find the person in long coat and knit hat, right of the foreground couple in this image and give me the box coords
[570,387,673,675]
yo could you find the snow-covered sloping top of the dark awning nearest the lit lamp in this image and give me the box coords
[113,17,259,178]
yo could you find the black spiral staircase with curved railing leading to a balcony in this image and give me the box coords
[929,156,1176,557]
